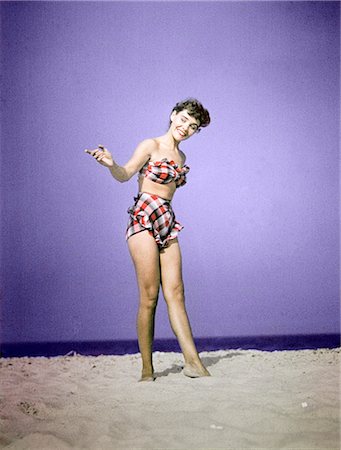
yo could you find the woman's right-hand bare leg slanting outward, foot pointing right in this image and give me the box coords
[160,239,210,377]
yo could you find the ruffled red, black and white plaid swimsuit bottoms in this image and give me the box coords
[126,192,183,248]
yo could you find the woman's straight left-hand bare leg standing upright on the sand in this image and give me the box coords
[128,231,160,381]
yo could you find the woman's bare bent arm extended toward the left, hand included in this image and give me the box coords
[85,139,155,183]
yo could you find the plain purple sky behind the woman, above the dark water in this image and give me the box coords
[1,2,339,342]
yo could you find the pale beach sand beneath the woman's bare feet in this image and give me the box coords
[0,349,340,450]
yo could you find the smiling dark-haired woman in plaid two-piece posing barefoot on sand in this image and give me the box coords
[85,99,210,381]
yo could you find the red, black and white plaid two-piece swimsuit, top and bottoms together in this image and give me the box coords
[126,158,189,248]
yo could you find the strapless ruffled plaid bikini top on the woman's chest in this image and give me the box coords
[140,158,189,188]
